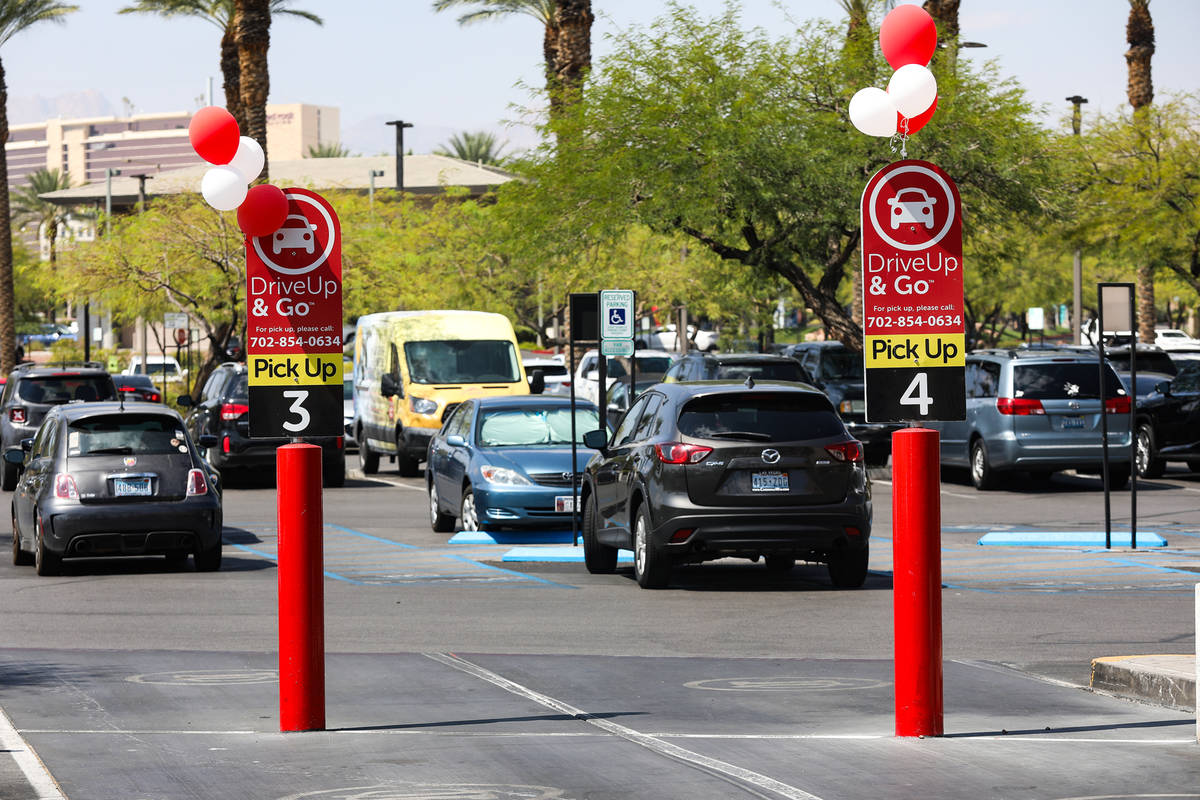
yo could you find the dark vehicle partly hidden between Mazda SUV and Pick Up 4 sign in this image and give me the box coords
[787,342,904,467]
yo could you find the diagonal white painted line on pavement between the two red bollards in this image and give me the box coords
[422,652,821,800]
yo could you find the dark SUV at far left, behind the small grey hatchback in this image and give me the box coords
[0,361,116,492]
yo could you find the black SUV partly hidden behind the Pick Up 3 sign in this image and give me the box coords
[176,361,346,487]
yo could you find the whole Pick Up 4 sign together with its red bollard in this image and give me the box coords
[862,161,966,736]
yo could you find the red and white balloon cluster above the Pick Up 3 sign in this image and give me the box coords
[187,106,288,236]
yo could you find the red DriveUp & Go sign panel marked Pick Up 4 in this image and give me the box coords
[862,161,966,422]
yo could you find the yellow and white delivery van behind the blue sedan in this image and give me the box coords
[353,311,540,477]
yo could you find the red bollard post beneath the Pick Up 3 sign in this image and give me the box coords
[276,444,325,732]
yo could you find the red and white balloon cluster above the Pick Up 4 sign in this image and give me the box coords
[850,6,937,137]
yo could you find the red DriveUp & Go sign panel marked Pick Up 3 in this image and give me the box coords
[246,188,343,437]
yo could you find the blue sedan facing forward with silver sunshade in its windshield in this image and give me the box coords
[425,395,609,533]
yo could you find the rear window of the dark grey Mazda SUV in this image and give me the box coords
[679,393,846,441]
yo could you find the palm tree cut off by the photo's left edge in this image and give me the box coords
[0,0,79,375]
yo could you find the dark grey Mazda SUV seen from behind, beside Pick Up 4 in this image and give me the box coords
[580,381,871,589]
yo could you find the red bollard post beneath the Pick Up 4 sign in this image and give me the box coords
[892,428,943,736]
